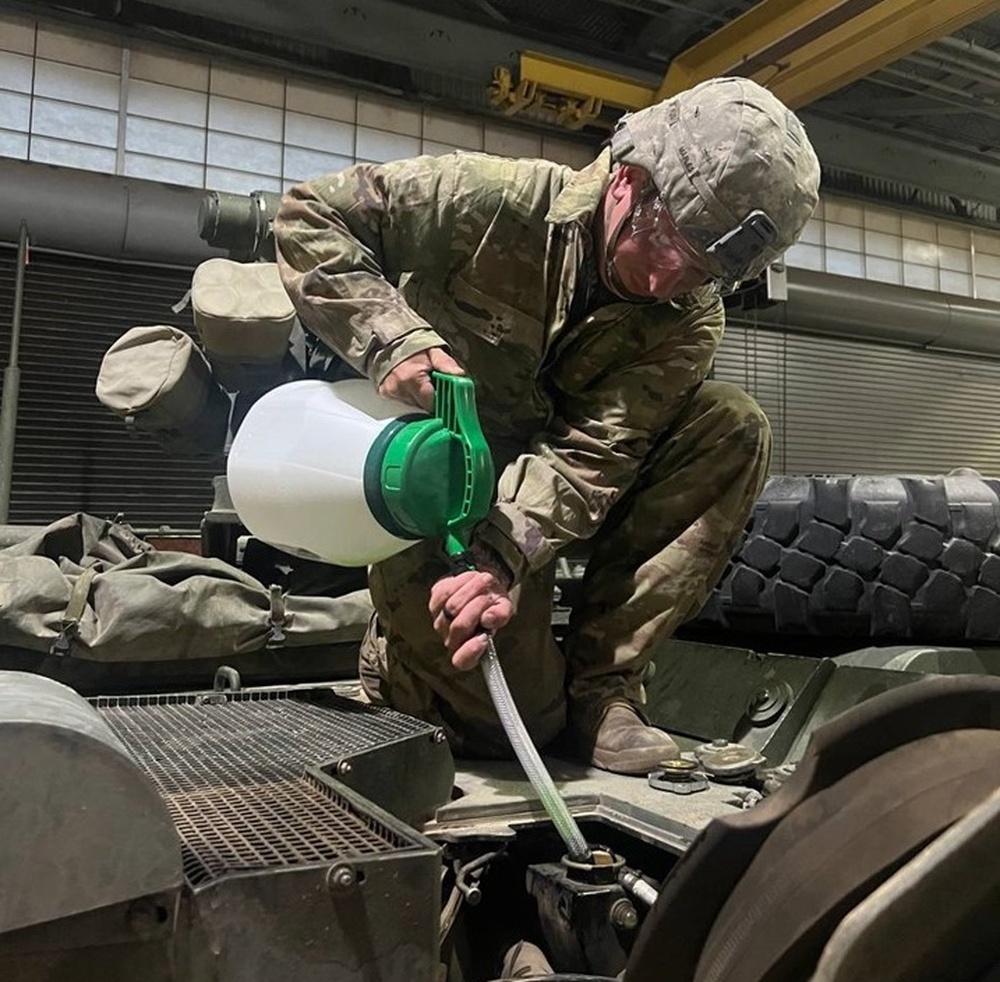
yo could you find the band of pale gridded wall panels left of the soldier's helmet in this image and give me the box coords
[0,15,594,193]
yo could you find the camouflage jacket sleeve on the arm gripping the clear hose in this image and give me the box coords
[477,293,724,580]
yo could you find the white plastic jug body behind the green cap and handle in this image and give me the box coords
[227,379,423,566]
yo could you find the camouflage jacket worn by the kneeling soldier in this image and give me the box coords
[274,151,724,579]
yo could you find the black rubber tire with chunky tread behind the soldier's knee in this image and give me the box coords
[692,470,1000,642]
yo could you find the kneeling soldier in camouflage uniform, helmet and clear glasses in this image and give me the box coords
[274,78,819,773]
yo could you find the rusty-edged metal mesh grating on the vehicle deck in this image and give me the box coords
[92,692,428,885]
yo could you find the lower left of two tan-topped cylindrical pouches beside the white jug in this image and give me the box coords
[95,324,231,454]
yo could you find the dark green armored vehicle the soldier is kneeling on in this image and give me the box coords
[0,195,1000,982]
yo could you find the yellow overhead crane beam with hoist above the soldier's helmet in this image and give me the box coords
[490,0,1000,129]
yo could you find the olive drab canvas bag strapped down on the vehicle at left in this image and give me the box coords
[0,513,372,662]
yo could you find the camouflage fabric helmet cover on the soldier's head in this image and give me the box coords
[611,78,819,279]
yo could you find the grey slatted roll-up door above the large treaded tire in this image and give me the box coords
[715,320,1000,475]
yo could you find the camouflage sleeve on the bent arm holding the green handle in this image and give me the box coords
[274,164,454,384]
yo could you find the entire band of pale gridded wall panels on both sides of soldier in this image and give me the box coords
[0,15,1000,301]
